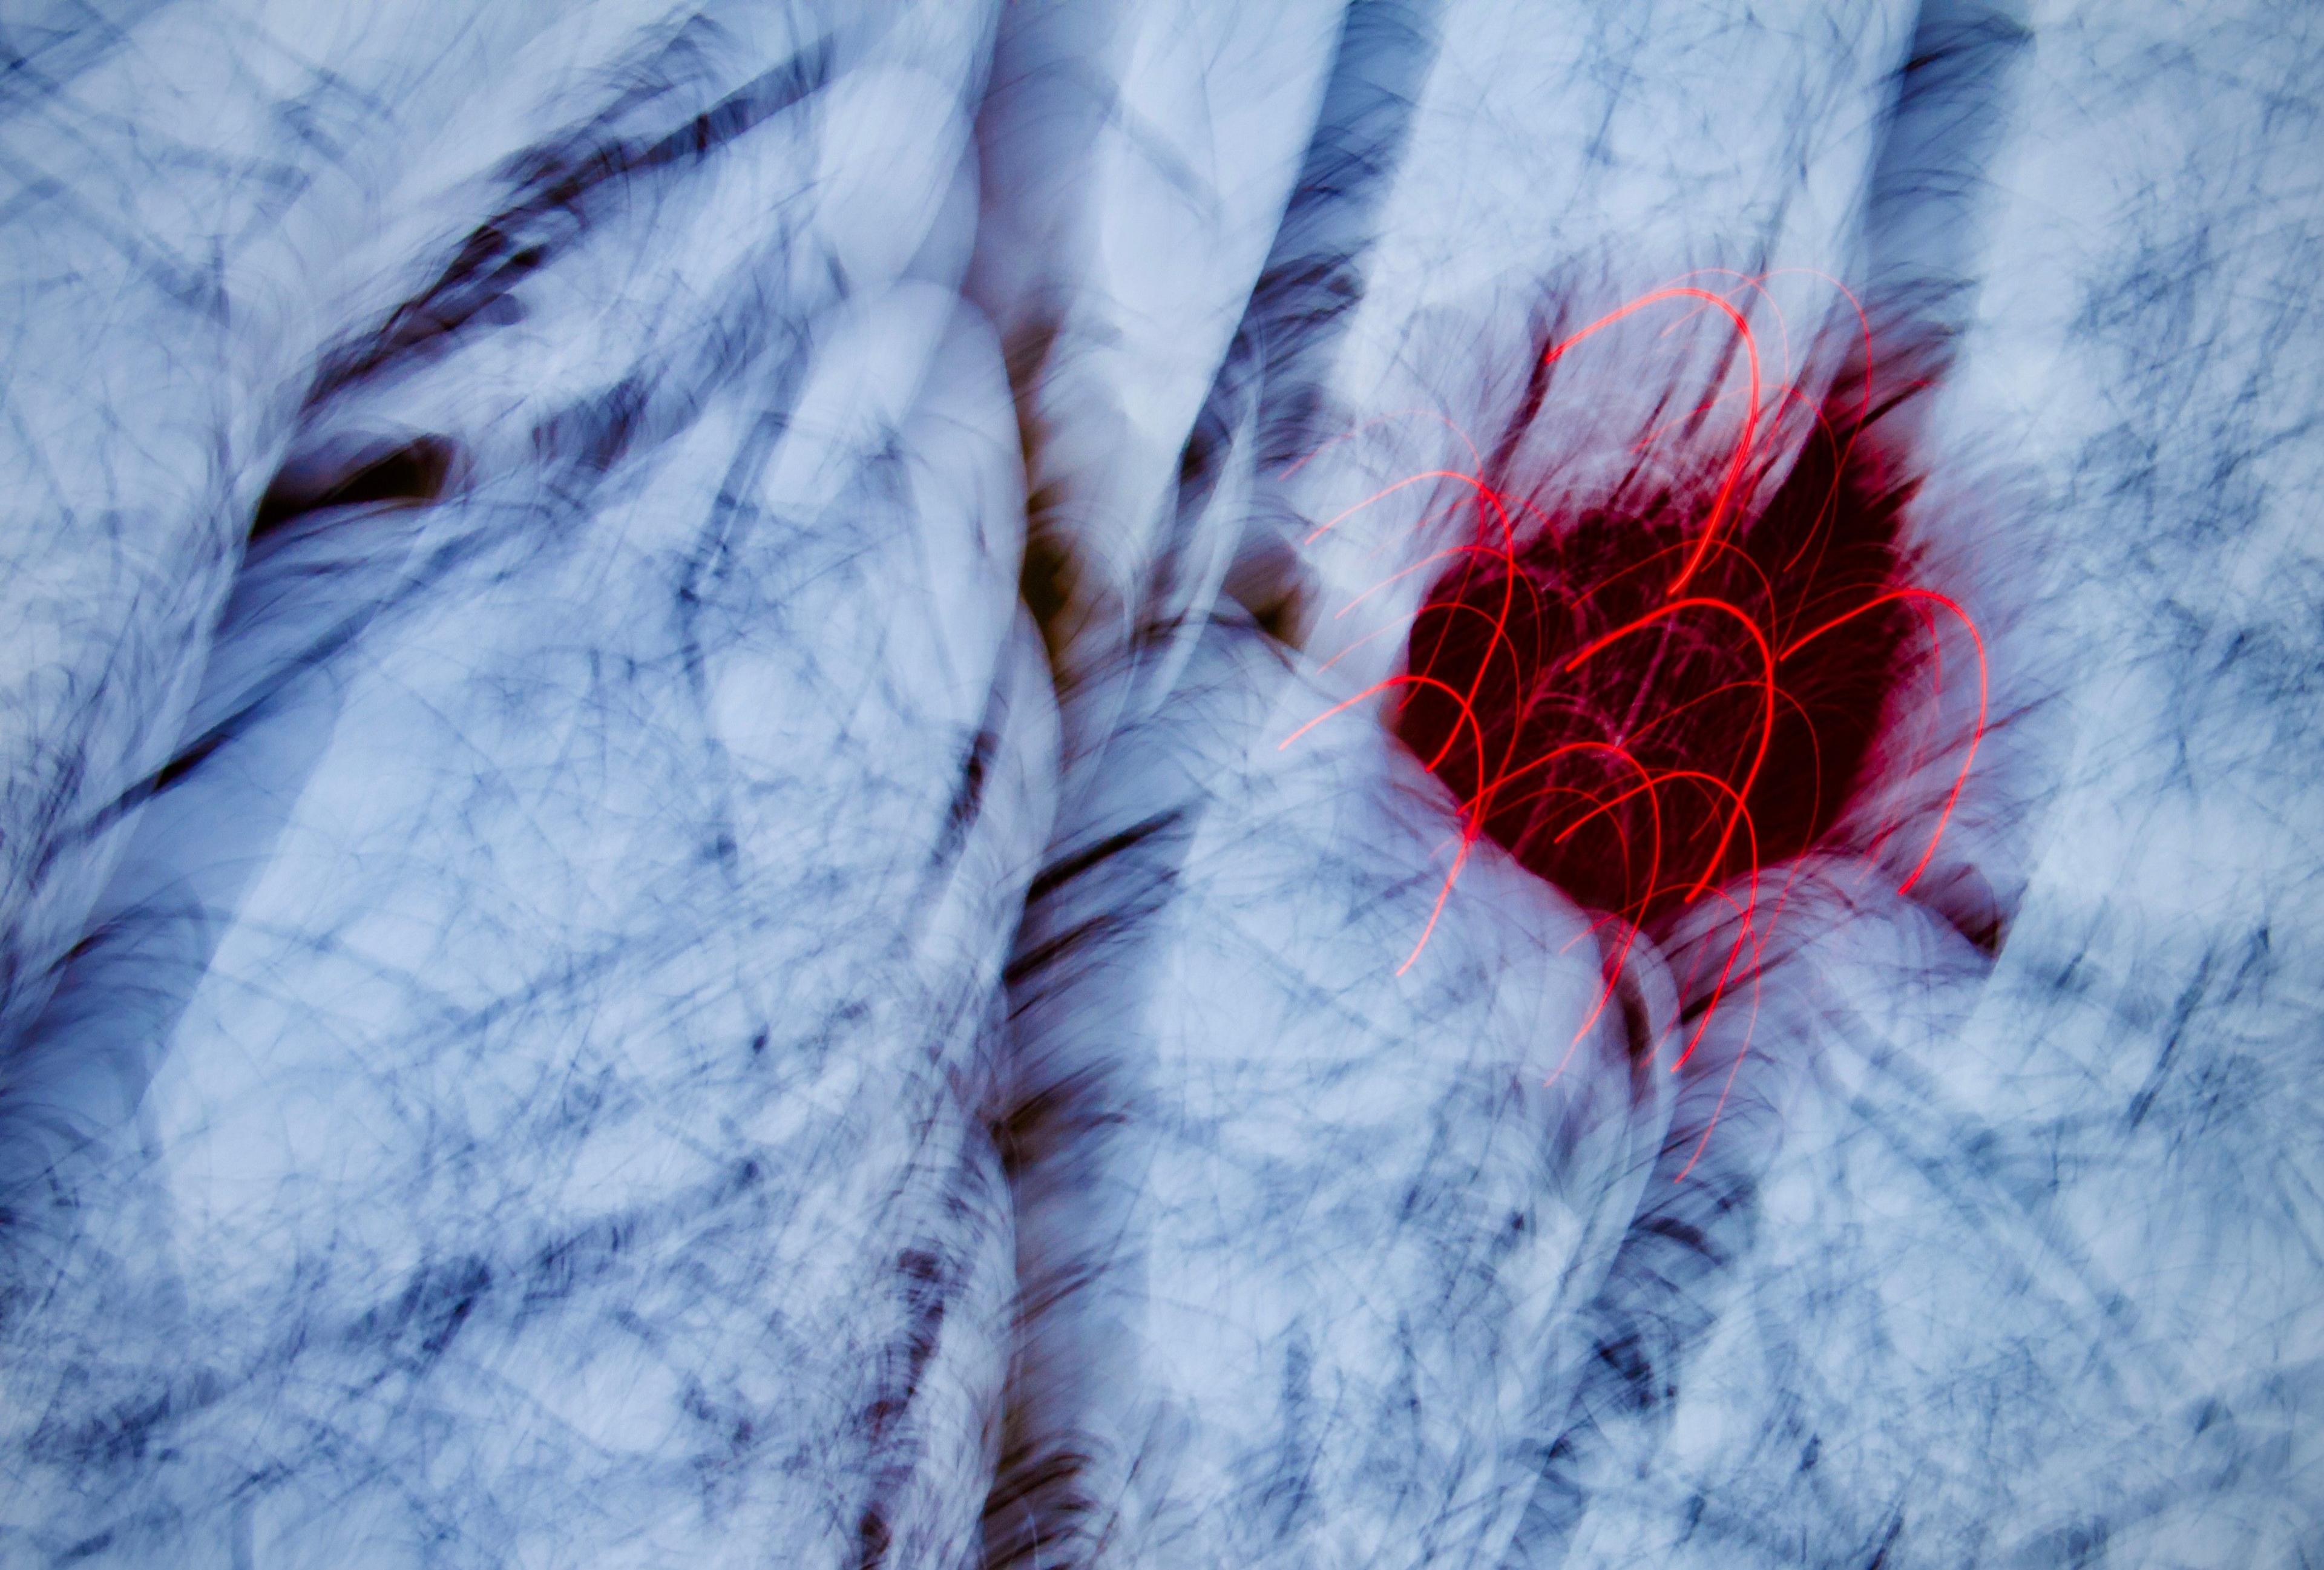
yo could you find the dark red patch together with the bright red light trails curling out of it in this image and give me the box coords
[1283,278,1987,1175]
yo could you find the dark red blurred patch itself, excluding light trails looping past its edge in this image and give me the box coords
[1394,407,1926,927]
